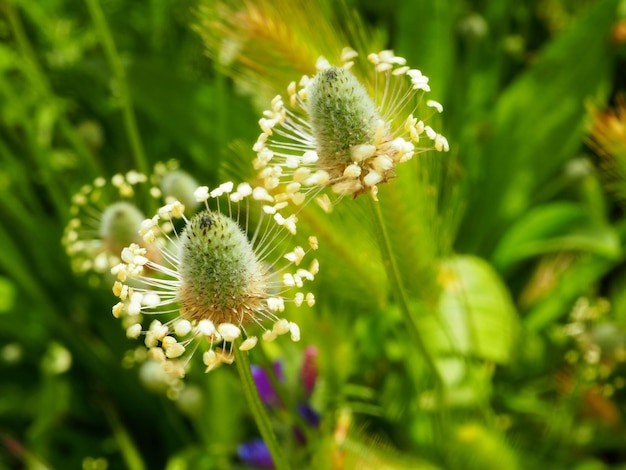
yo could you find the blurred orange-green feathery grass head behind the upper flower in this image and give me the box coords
[194,0,381,109]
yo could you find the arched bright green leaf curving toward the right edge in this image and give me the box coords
[493,202,621,271]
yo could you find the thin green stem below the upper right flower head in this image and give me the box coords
[370,199,443,392]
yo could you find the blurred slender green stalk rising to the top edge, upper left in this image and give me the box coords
[86,0,149,175]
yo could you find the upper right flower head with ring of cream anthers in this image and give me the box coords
[254,48,449,209]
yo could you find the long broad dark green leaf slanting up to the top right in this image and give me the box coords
[458,0,618,253]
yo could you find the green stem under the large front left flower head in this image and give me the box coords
[233,344,290,470]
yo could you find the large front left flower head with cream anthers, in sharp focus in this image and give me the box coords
[111,183,318,376]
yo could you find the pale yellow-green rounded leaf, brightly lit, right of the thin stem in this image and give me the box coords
[420,256,518,364]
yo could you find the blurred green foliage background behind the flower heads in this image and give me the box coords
[0,0,626,470]
